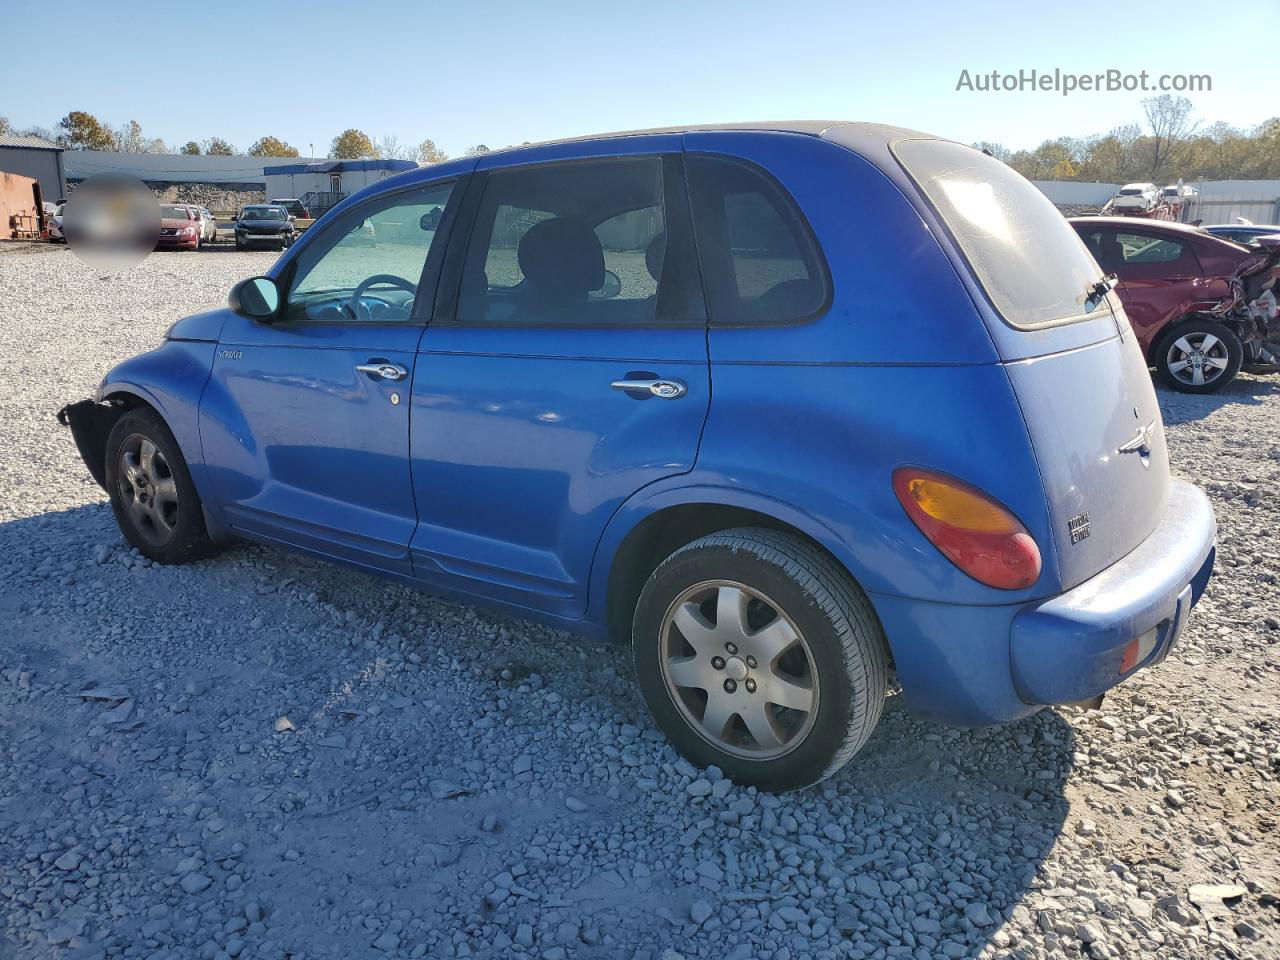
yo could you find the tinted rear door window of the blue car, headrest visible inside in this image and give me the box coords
[457,157,687,325]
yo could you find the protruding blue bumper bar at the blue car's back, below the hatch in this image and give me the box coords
[1010,480,1217,704]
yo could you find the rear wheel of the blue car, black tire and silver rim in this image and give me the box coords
[632,529,888,791]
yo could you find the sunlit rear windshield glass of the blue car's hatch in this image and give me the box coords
[893,140,1106,326]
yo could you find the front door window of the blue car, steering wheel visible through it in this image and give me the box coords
[285,183,454,323]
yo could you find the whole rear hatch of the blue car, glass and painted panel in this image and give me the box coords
[893,140,1169,589]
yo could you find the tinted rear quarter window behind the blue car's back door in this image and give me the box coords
[686,155,827,324]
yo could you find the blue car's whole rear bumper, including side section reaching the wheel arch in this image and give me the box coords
[872,480,1217,726]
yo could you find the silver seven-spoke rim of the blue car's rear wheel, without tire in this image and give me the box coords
[659,580,819,760]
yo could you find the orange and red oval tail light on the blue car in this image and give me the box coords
[893,467,1041,590]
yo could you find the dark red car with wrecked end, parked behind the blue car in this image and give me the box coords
[1070,216,1280,393]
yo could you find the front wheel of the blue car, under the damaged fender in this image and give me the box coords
[106,408,211,563]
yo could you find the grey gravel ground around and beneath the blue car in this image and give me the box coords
[0,243,1280,960]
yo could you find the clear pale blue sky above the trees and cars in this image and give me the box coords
[0,0,1280,155]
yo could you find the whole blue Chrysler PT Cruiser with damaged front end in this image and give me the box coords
[60,123,1216,790]
